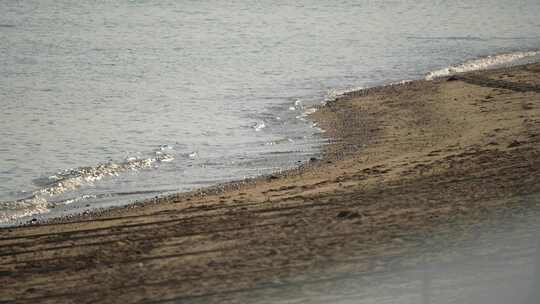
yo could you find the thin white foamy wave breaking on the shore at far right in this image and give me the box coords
[425,50,540,80]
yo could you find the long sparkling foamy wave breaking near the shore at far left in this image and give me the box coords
[0,145,174,223]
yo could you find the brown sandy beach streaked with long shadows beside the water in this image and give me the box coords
[0,64,540,303]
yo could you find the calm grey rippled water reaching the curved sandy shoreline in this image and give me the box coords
[0,0,540,224]
